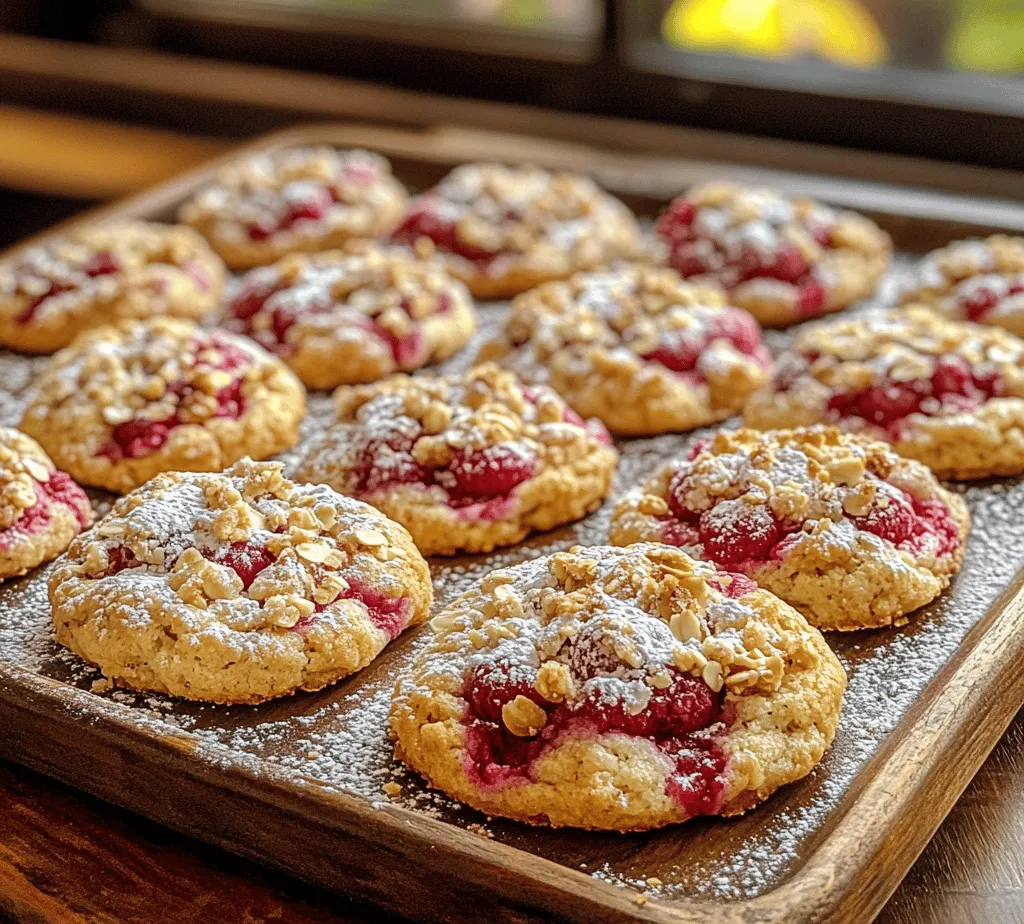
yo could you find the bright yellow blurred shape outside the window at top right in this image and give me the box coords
[662,0,888,68]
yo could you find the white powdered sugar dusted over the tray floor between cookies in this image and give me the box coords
[0,250,1024,900]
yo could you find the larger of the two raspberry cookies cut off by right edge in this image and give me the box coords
[744,307,1024,478]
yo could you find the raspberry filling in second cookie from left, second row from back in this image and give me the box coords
[229,274,430,369]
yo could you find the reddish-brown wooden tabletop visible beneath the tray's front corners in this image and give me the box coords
[0,711,1024,924]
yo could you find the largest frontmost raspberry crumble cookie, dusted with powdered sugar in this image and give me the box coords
[391,544,846,831]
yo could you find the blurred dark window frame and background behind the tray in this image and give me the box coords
[0,0,1024,245]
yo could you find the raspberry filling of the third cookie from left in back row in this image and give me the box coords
[656,197,834,318]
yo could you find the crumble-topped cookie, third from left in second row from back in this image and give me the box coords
[479,266,771,435]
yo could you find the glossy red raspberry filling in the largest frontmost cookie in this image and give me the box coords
[462,651,726,815]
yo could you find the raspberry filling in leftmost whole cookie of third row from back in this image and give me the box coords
[96,334,252,461]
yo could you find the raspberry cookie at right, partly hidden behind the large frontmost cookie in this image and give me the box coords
[609,427,970,630]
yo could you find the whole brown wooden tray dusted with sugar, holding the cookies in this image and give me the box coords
[0,126,1024,924]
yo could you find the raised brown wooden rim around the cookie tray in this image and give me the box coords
[6,124,1024,924]
